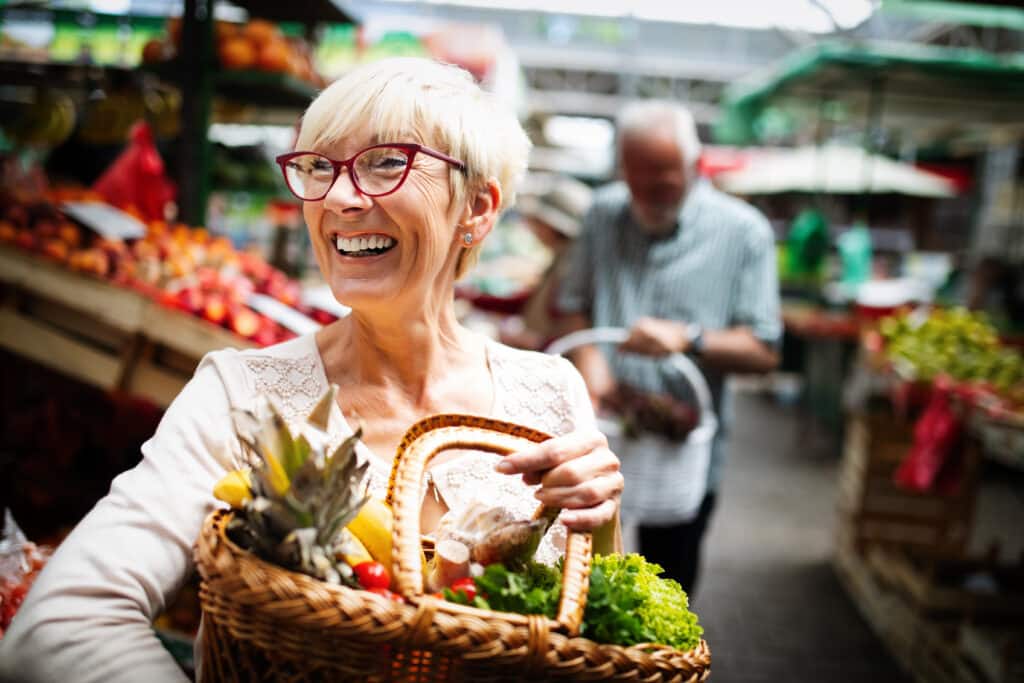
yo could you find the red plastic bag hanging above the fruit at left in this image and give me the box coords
[92,121,177,220]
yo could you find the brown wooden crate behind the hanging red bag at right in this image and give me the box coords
[838,412,979,557]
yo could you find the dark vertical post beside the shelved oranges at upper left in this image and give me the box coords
[177,0,214,225]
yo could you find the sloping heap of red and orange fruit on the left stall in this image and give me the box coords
[0,188,335,346]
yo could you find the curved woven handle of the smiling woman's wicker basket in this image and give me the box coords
[385,415,592,635]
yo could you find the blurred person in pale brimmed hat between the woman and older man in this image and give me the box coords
[502,175,591,349]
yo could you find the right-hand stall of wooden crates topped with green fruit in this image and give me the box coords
[835,309,1024,682]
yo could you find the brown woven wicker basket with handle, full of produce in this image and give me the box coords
[196,415,711,683]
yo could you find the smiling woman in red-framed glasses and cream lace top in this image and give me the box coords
[0,58,623,683]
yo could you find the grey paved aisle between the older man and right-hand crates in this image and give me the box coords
[693,392,909,683]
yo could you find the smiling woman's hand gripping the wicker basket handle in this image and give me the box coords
[496,429,623,531]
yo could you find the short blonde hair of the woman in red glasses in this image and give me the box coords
[295,57,530,278]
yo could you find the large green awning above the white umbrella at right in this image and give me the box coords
[715,42,1024,144]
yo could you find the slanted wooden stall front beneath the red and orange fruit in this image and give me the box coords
[0,247,252,407]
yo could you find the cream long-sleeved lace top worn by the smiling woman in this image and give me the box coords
[0,335,594,683]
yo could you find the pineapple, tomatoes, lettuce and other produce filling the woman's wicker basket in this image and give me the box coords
[214,387,702,650]
